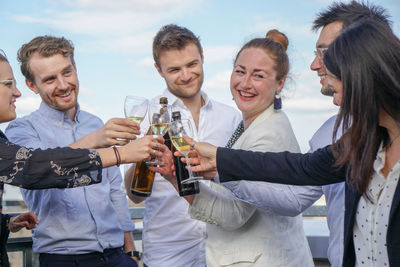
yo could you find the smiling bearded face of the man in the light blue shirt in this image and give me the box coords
[26,53,79,119]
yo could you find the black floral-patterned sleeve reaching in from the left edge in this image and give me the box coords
[0,137,102,192]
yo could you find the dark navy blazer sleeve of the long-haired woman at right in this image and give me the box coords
[217,146,346,185]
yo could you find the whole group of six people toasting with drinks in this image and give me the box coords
[0,1,400,267]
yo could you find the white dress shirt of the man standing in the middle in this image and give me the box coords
[143,90,241,267]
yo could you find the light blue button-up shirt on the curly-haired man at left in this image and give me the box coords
[6,102,134,254]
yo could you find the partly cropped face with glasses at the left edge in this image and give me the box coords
[0,61,21,122]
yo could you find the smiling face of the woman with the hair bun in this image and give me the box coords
[231,48,285,126]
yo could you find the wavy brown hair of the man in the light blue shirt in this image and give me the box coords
[18,35,75,82]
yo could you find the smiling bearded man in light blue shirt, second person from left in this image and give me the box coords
[6,36,139,267]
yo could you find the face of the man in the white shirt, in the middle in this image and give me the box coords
[155,43,204,99]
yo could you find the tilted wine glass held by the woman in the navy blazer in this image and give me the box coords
[168,119,203,184]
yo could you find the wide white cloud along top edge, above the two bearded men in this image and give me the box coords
[14,0,202,38]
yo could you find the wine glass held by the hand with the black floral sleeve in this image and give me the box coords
[146,103,171,166]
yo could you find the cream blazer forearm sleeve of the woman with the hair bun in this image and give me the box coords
[189,183,256,231]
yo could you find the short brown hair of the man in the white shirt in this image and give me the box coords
[153,24,203,68]
